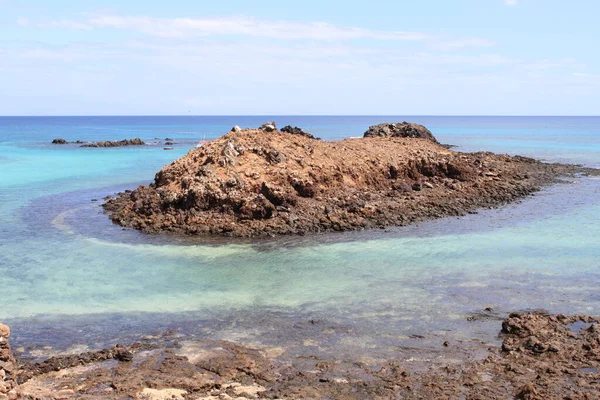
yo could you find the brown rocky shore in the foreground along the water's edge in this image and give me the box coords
[13,313,600,400]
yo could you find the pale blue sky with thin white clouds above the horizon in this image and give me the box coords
[0,0,600,115]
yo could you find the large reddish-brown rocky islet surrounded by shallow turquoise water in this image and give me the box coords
[104,122,598,237]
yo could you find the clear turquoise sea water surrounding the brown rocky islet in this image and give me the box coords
[0,117,600,357]
